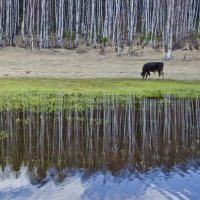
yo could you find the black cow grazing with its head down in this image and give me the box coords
[141,62,164,79]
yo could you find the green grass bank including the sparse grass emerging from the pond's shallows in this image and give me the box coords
[0,78,200,112]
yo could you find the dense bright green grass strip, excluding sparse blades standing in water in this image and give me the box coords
[0,78,200,97]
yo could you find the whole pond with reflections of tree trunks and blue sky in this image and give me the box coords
[0,96,200,200]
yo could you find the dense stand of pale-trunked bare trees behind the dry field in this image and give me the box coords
[0,0,200,60]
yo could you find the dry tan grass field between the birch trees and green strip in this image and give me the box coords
[0,47,200,81]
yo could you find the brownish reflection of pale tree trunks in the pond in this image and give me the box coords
[0,96,200,180]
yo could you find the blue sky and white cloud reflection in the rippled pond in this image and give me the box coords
[0,164,200,200]
